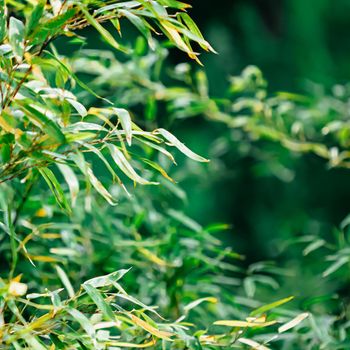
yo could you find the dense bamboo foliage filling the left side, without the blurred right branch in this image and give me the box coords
[0,0,309,349]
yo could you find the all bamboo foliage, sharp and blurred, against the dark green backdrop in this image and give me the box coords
[0,0,349,349]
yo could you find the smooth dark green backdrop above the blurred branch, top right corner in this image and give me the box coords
[192,0,350,92]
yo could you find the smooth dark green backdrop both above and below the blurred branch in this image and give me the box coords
[172,0,350,264]
